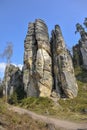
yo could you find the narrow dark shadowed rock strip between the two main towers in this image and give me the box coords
[51,25,63,97]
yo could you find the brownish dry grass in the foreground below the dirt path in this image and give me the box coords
[0,99,48,130]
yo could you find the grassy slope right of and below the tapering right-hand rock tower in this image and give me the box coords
[59,67,87,121]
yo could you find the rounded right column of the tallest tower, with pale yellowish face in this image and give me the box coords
[35,19,52,97]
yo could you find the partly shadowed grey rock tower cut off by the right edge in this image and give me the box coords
[73,32,87,70]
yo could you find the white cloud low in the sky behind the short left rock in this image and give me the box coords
[0,62,23,79]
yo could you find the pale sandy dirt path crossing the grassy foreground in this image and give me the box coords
[9,106,87,130]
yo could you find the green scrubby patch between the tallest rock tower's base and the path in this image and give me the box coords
[20,97,54,115]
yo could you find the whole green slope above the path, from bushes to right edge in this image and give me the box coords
[17,67,87,121]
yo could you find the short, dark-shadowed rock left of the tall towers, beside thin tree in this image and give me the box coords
[3,64,23,95]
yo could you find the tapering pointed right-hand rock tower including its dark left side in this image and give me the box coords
[51,25,78,98]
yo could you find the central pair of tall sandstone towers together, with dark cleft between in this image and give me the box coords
[23,19,78,98]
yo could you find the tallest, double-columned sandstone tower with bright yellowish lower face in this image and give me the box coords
[23,19,52,97]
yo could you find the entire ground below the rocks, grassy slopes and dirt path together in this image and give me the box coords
[0,68,87,130]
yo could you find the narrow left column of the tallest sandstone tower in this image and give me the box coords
[23,23,39,97]
